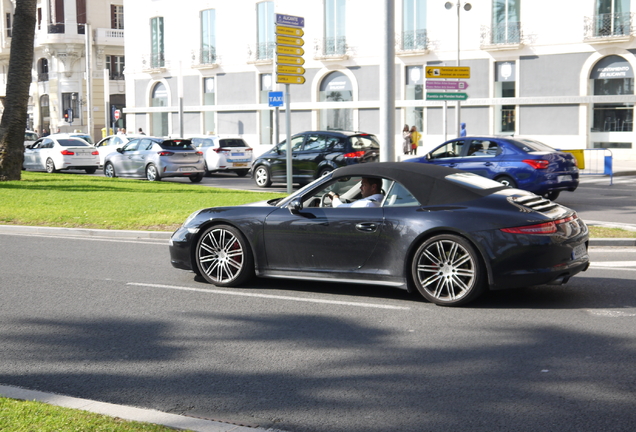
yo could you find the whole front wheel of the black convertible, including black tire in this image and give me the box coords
[195,225,254,286]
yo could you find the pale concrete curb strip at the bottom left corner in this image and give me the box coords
[0,385,273,432]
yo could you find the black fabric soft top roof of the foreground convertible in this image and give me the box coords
[333,162,507,205]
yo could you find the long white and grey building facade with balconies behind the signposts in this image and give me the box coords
[125,0,636,159]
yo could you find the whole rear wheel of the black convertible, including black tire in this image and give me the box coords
[411,234,486,306]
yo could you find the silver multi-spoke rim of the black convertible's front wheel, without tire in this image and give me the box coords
[197,227,245,284]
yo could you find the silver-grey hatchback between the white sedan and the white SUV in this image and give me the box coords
[104,136,205,183]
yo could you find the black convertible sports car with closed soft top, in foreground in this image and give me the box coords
[170,162,589,306]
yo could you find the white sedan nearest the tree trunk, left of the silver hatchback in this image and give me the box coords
[22,135,99,174]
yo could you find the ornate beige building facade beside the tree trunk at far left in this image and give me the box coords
[0,0,126,139]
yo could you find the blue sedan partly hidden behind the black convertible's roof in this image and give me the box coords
[406,136,579,200]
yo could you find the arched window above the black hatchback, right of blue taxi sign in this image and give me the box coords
[320,72,353,130]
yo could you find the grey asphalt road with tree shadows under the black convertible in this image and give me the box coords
[0,234,636,432]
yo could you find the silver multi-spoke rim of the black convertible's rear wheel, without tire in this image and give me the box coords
[414,239,478,303]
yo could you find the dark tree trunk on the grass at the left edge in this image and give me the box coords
[0,0,37,181]
